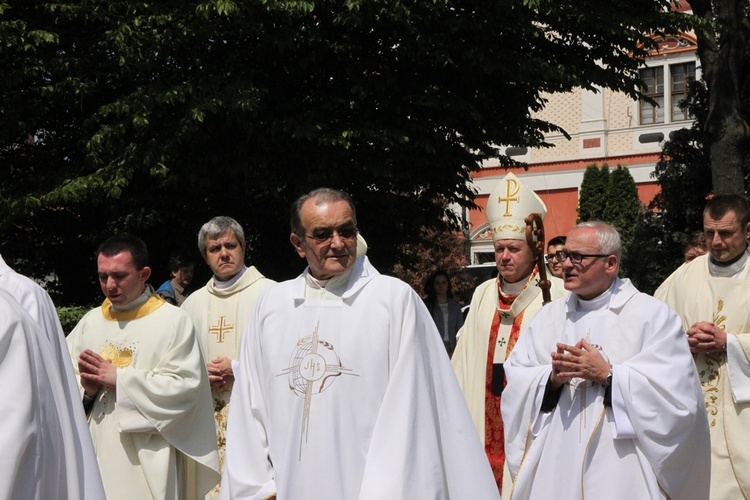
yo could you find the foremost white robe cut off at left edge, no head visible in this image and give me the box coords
[0,288,104,500]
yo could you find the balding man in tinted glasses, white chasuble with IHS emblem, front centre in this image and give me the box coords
[221,188,497,500]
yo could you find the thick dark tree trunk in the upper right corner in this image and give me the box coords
[690,0,750,194]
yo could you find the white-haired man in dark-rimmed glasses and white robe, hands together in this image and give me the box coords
[502,222,710,500]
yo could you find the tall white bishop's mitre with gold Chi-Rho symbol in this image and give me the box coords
[487,173,547,241]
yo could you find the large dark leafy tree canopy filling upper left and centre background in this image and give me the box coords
[0,0,685,302]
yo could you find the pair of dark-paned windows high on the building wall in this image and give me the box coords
[640,62,695,125]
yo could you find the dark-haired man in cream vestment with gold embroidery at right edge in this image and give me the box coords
[655,195,750,499]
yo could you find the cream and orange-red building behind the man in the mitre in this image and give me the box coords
[465,17,700,265]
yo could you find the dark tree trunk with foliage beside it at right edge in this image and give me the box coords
[633,0,750,292]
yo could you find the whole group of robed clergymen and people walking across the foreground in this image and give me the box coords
[0,182,750,500]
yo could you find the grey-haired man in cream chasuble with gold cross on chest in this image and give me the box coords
[182,216,275,498]
